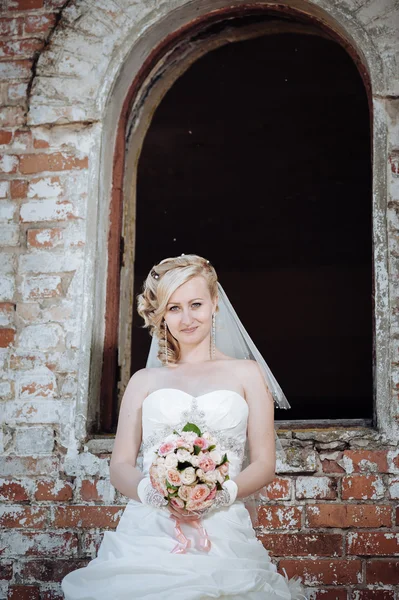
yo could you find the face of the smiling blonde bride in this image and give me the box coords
[165,275,216,345]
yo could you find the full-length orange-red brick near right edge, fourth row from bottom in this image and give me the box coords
[306,504,392,527]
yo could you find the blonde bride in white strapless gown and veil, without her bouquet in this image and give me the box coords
[61,255,306,600]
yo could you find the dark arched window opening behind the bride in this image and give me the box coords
[131,33,374,420]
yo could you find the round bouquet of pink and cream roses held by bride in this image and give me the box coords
[149,423,230,513]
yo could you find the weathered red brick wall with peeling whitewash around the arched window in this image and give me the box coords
[0,0,399,600]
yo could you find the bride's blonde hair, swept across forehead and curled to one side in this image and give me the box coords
[137,254,217,364]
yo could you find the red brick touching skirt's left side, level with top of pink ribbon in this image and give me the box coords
[54,505,123,529]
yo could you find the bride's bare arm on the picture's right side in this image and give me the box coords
[234,361,276,498]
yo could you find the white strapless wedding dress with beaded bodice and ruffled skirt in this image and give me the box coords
[61,388,306,600]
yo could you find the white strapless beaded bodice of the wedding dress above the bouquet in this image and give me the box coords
[141,388,249,477]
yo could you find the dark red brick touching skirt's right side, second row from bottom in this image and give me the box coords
[278,558,362,586]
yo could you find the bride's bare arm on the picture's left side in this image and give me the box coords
[110,369,148,502]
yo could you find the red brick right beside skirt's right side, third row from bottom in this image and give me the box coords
[258,533,343,556]
